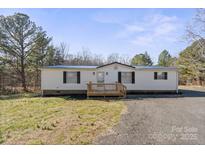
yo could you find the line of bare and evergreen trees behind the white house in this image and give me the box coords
[0,9,205,93]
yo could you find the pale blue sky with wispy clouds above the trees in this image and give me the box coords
[0,9,196,62]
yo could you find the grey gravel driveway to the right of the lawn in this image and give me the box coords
[94,89,205,144]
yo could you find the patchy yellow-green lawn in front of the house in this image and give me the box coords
[0,97,125,144]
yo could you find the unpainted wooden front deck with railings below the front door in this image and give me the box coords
[87,82,127,97]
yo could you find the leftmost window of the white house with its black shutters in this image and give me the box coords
[63,72,80,83]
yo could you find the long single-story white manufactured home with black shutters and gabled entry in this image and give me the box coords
[41,62,178,95]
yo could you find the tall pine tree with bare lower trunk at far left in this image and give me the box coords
[0,13,44,91]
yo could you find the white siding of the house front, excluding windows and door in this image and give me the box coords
[41,64,178,91]
